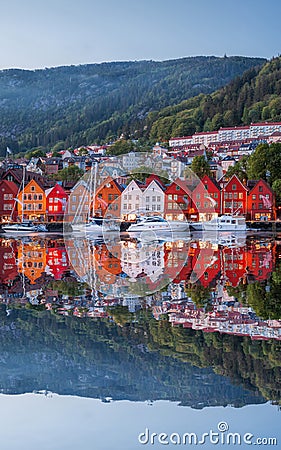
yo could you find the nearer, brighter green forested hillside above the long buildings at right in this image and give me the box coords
[146,57,281,140]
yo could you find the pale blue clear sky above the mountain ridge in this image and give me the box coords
[0,0,281,69]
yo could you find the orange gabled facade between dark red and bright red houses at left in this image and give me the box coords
[18,180,46,220]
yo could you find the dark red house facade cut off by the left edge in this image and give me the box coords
[0,180,18,222]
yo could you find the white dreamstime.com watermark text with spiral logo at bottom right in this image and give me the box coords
[138,421,277,448]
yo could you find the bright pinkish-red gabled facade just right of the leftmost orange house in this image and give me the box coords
[45,184,68,222]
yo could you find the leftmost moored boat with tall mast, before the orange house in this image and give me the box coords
[2,166,48,236]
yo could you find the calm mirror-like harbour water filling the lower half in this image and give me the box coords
[0,235,281,450]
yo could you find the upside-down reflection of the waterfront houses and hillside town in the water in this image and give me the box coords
[0,236,281,339]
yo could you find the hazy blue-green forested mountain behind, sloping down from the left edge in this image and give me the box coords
[0,56,265,155]
